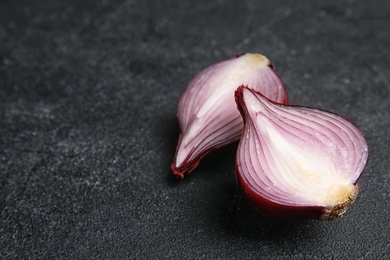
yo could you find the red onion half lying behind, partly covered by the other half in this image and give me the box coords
[171,53,287,178]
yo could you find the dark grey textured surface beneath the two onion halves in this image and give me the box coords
[0,0,390,259]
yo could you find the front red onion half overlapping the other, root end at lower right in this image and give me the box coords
[235,86,368,219]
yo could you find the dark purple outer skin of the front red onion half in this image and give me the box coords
[235,86,366,221]
